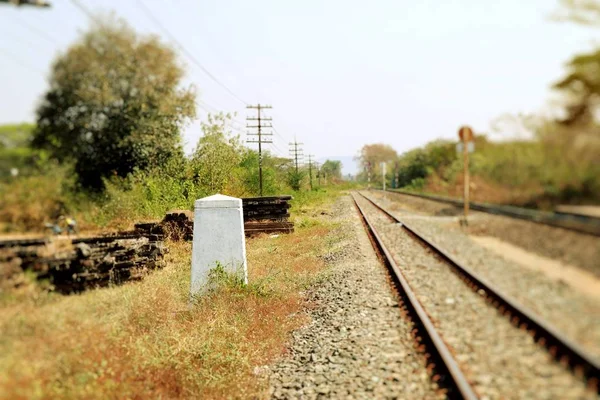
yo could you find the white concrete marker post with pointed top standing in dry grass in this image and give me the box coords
[190,194,248,295]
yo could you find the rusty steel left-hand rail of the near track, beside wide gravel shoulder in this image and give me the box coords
[353,196,478,399]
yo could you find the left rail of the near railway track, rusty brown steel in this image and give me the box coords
[353,192,478,399]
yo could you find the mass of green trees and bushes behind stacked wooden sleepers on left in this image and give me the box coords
[0,16,341,234]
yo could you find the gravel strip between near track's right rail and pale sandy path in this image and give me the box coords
[366,193,600,360]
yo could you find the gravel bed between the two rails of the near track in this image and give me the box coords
[359,192,596,399]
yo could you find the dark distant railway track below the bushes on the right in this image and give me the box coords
[379,189,600,236]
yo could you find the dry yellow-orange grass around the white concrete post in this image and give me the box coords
[0,189,341,399]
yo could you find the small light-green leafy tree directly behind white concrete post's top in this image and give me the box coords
[192,113,243,193]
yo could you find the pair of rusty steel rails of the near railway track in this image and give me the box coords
[353,192,600,398]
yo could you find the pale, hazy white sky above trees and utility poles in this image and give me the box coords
[0,0,598,173]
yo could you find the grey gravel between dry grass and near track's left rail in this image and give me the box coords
[270,196,443,399]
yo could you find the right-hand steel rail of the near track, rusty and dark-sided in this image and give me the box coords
[358,192,600,392]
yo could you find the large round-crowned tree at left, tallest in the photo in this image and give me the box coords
[32,19,195,189]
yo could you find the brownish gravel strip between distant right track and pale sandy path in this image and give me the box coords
[369,191,600,277]
